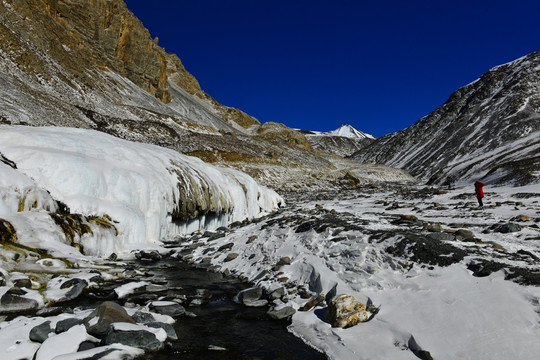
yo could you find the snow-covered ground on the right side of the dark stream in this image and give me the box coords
[187,185,540,360]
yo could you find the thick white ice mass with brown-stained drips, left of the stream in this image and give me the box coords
[0,125,282,256]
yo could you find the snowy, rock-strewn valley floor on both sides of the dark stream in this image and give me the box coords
[0,184,540,360]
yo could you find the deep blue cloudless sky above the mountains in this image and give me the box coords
[125,0,540,136]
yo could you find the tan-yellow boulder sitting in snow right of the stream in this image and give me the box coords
[327,295,369,328]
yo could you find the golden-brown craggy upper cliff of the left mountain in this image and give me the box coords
[0,0,258,127]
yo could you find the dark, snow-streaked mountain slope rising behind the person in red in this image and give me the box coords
[353,52,540,184]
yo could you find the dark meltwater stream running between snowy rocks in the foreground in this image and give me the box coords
[126,258,326,360]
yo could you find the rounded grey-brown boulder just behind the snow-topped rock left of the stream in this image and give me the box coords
[84,301,136,338]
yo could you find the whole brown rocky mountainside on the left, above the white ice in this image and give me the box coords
[0,0,414,187]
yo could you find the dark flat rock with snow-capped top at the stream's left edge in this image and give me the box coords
[103,324,163,351]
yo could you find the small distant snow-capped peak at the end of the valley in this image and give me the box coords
[301,124,375,157]
